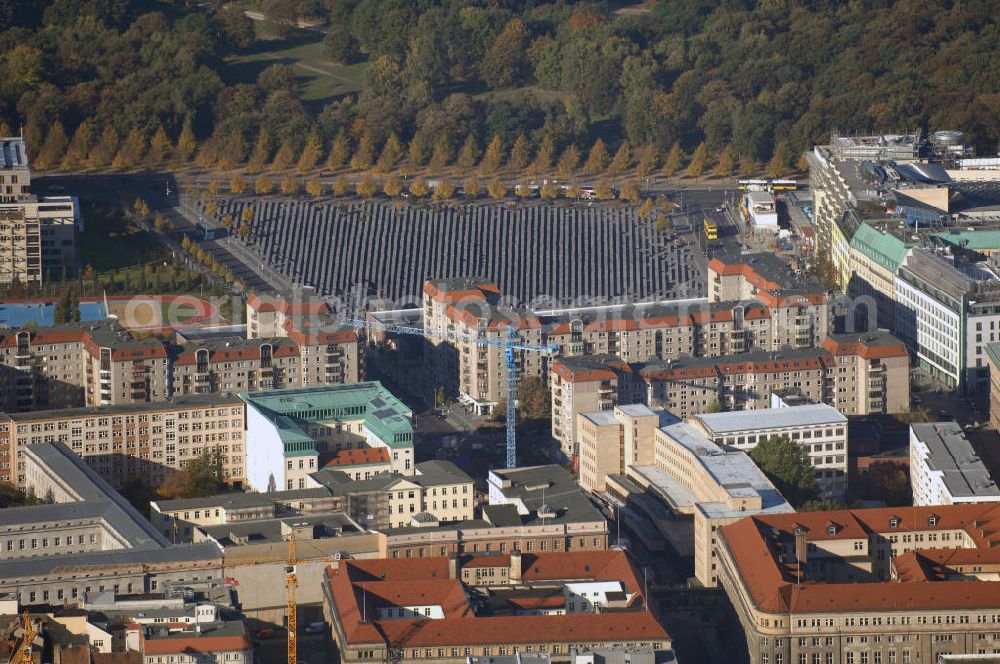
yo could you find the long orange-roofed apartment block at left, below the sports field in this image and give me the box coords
[0,312,361,411]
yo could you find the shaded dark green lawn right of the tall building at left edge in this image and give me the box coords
[77,202,169,273]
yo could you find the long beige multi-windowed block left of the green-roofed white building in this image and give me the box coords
[0,394,248,488]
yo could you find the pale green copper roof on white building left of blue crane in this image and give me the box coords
[240,381,413,456]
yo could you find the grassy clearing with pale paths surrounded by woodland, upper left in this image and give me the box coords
[223,30,368,102]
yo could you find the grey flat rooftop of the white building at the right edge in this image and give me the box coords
[910,422,1000,500]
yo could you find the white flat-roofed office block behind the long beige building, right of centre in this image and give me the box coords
[691,404,848,501]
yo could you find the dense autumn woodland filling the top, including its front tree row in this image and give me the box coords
[0,0,1000,175]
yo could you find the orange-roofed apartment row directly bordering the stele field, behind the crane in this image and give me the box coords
[422,254,829,412]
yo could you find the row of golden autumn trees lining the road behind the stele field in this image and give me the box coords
[23,114,803,180]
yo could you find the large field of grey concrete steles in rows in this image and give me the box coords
[219,199,704,303]
